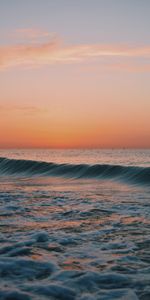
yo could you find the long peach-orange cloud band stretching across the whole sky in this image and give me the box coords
[0,30,150,69]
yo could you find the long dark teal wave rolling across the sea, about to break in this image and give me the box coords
[0,157,150,184]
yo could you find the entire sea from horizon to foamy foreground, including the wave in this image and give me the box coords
[0,149,150,300]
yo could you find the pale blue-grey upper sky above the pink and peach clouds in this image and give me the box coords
[0,0,150,44]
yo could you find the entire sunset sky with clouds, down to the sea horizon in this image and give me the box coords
[0,0,150,148]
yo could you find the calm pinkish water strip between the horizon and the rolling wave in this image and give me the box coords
[0,149,150,167]
